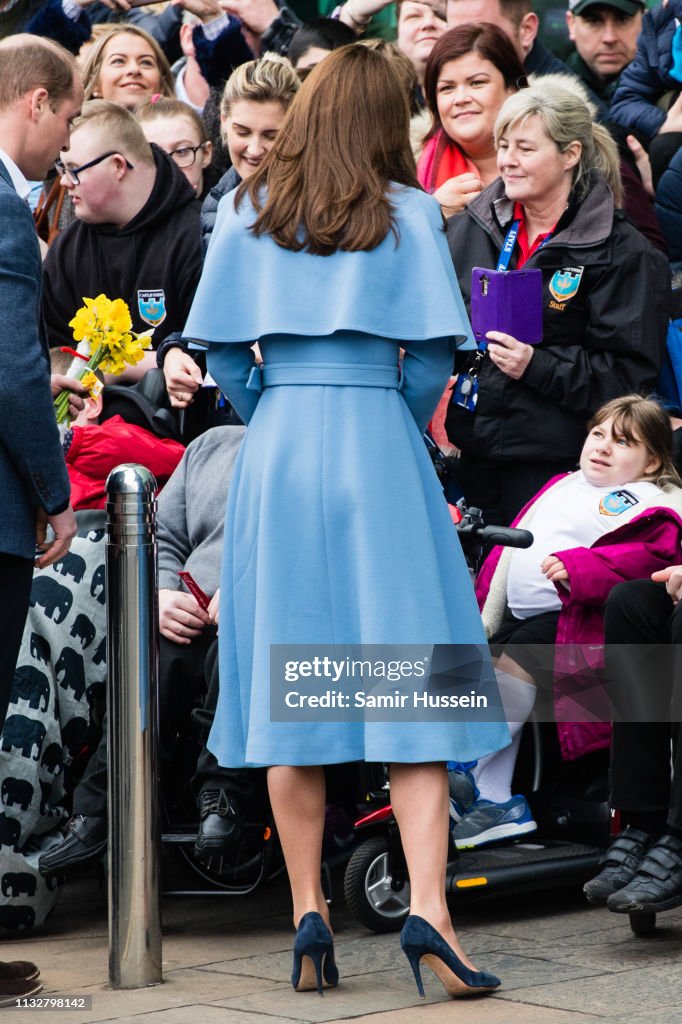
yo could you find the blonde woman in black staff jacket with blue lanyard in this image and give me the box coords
[445,77,670,523]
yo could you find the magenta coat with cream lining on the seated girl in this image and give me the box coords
[476,474,682,761]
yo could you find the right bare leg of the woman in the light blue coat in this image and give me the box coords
[390,763,475,970]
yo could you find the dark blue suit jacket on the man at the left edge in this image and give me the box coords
[0,161,71,558]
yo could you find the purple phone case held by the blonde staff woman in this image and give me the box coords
[471,266,543,345]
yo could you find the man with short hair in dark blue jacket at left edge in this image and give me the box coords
[0,35,83,1007]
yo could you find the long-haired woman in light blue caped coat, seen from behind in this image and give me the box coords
[184,46,509,995]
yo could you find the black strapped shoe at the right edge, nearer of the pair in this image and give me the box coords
[606,836,682,913]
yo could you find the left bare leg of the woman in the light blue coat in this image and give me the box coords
[267,765,329,928]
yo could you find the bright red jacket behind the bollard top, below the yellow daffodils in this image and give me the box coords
[67,416,184,511]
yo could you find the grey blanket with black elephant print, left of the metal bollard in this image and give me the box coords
[0,529,106,931]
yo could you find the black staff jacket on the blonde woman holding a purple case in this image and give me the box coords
[445,180,670,462]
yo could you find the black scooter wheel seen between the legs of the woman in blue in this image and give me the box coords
[343,836,410,933]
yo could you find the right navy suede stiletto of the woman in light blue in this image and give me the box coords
[400,914,502,998]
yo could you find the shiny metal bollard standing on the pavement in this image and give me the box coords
[106,464,162,988]
